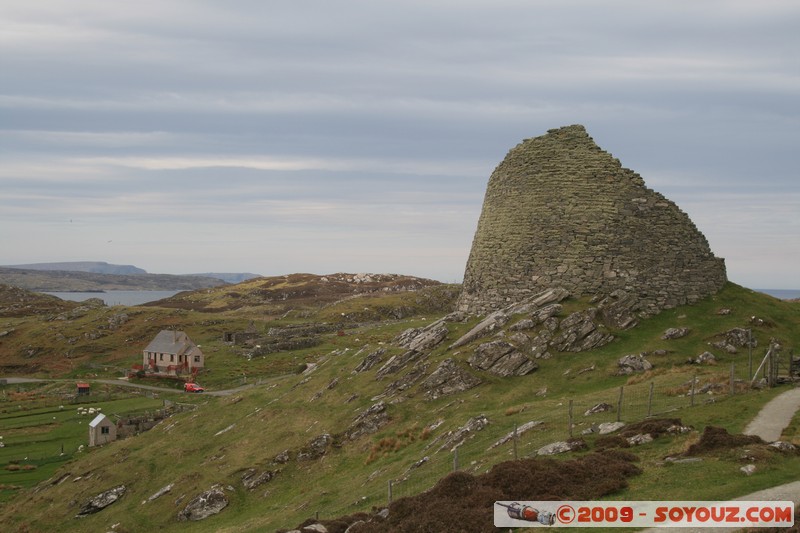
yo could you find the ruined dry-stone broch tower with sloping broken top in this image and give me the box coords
[458,125,727,314]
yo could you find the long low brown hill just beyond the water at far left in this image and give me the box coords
[0,267,226,292]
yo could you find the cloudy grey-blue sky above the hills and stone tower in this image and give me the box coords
[0,0,800,289]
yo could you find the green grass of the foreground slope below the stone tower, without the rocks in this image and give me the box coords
[0,284,800,531]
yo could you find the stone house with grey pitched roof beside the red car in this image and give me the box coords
[142,329,205,376]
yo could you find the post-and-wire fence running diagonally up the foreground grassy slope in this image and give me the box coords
[309,352,800,519]
